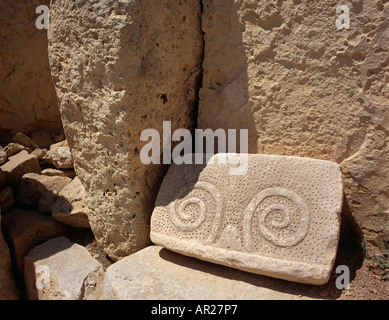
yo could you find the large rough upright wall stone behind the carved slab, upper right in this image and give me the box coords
[198,0,389,245]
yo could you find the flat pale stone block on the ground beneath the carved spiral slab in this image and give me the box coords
[103,246,318,300]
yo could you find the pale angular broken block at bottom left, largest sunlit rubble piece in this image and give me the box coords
[24,237,104,300]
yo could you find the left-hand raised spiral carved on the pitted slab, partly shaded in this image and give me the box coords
[170,181,223,243]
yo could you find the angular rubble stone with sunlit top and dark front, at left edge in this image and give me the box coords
[0,150,42,190]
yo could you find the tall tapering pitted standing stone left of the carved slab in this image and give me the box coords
[49,0,203,260]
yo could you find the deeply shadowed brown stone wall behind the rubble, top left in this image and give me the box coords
[0,0,62,133]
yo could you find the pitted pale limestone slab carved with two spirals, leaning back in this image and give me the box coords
[151,154,343,285]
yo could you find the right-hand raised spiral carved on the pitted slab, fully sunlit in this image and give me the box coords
[243,187,310,249]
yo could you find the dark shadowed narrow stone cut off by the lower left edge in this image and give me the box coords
[0,210,19,300]
